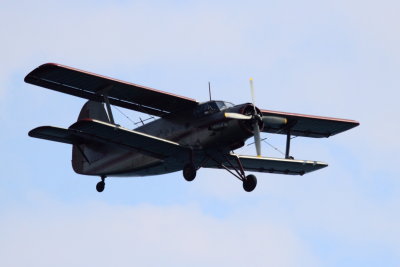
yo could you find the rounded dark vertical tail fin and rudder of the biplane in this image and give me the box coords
[72,101,110,174]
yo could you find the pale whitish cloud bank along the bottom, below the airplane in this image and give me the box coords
[0,204,317,266]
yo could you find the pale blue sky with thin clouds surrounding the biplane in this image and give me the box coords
[0,0,400,266]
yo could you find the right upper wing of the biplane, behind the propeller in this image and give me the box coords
[261,110,360,137]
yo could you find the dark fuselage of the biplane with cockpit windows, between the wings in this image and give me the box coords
[74,101,252,176]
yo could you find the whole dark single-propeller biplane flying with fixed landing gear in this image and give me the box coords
[24,63,359,192]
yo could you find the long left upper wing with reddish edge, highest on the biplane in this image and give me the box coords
[25,63,198,117]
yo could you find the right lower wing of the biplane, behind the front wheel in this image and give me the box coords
[203,154,328,175]
